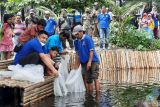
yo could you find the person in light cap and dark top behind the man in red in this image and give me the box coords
[25,9,38,27]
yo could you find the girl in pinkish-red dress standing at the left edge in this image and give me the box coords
[0,14,14,60]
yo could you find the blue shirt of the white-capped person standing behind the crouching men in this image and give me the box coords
[45,19,56,36]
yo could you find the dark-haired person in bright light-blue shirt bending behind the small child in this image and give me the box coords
[45,31,69,54]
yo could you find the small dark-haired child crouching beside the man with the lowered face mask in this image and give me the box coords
[47,46,61,75]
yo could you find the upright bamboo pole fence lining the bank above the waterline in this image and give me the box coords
[70,50,160,70]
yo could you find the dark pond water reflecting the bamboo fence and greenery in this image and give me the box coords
[0,69,160,107]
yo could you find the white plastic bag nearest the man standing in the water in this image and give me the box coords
[65,66,86,93]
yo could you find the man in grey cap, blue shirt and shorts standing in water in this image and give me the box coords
[73,25,100,92]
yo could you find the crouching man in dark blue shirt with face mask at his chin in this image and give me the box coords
[14,31,58,77]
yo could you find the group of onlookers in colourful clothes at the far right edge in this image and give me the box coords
[131,7,160,40]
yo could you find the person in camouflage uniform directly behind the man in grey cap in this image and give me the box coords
[81,8,93,36]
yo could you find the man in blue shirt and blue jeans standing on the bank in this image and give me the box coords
[97,7,111,50]
